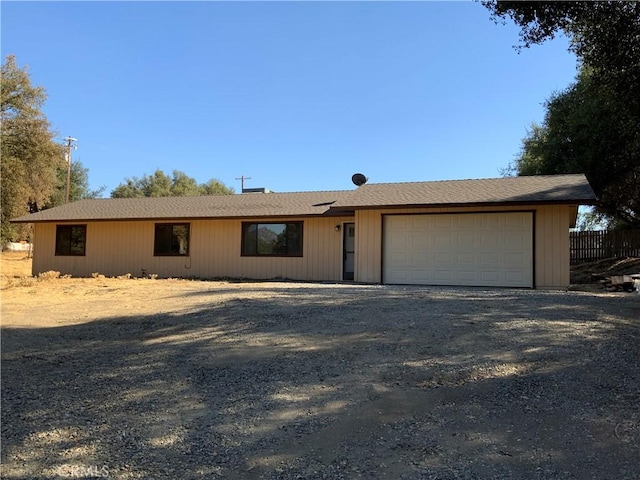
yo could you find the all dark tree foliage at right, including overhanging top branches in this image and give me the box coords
[482,0,640,226]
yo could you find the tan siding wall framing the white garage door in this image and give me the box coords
[355,205,575,289]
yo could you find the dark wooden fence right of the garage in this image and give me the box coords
[570,230,640,265]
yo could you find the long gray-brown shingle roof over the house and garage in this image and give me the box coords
[13,175,595,223]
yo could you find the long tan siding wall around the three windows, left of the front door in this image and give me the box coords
[33,217,353,281]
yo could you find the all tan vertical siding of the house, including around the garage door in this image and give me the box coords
[33,205,575,288]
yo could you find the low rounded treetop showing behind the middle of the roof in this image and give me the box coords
[111,169,234,198]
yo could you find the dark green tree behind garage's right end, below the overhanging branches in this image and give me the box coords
[512,69,640,226]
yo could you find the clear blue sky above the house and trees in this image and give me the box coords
[0,1,576,196]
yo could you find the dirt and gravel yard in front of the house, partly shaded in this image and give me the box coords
[1,254,640,480]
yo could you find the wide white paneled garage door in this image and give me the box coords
[382,212,533,287]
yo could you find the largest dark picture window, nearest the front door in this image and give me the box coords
[242,222,302,257]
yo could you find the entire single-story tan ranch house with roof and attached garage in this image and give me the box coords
[13,175,595,288]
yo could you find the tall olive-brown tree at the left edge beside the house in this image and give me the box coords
[0,55,65,245]
